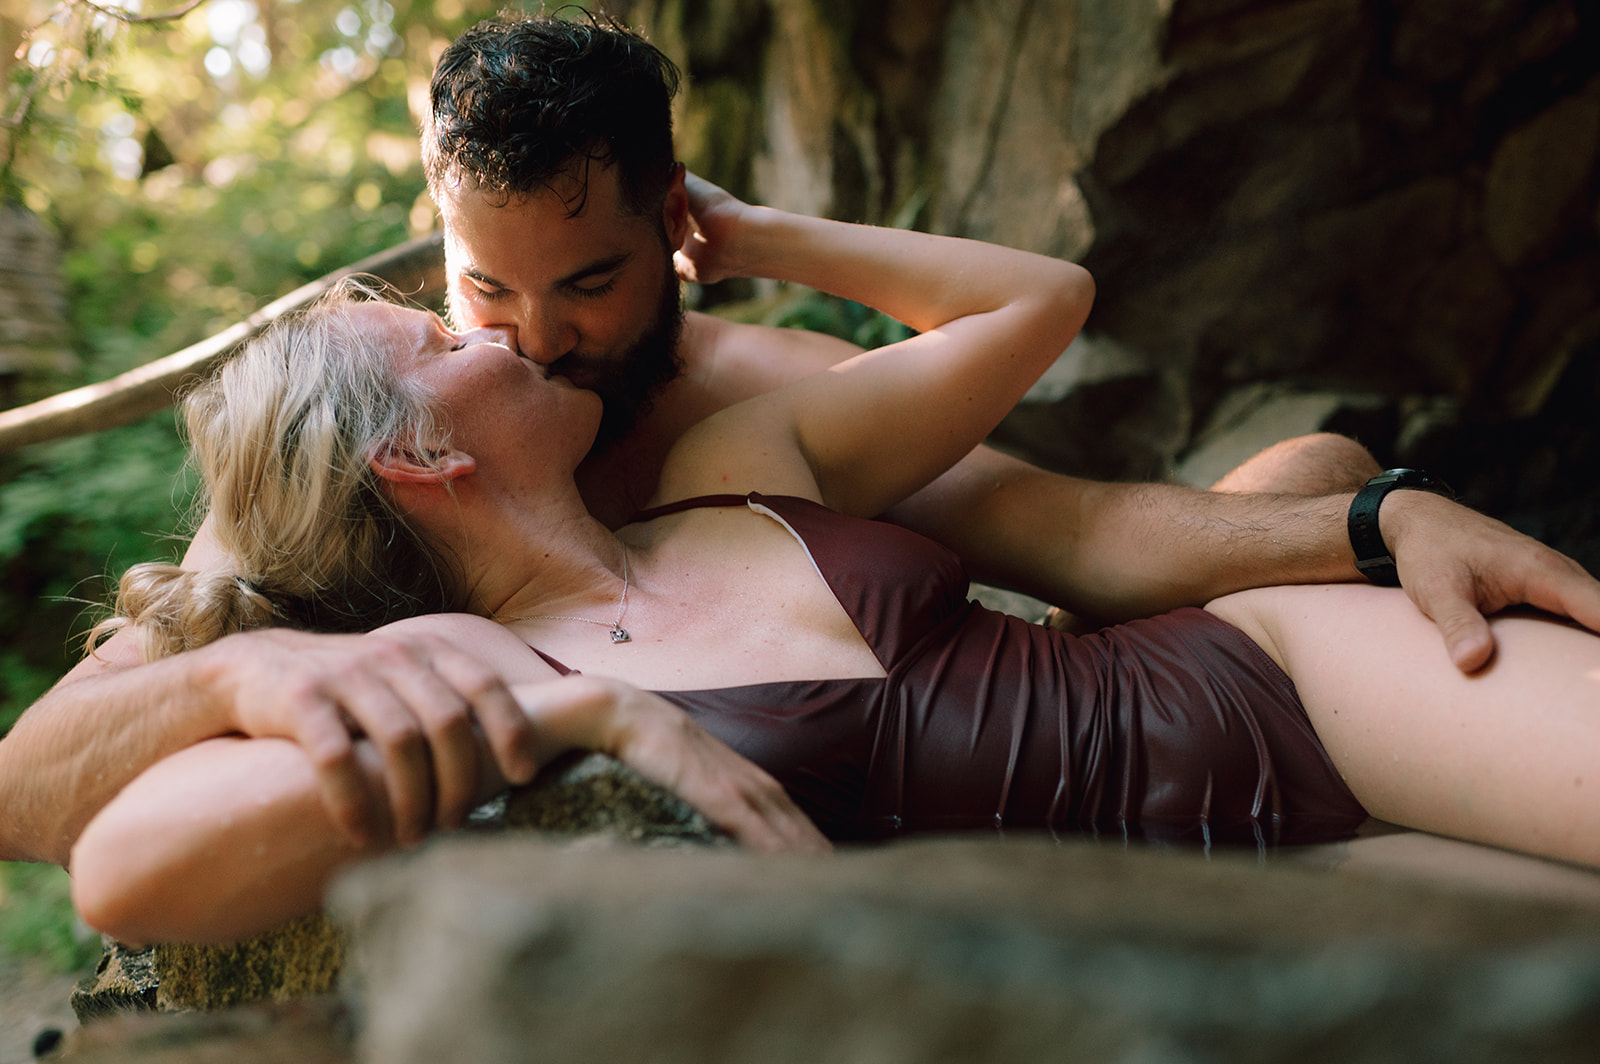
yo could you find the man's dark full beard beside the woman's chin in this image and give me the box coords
[550,262,683,453]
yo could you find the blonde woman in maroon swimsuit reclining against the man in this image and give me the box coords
[74,182,1600,939]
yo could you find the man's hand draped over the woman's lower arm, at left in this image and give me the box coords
[194,629,538,843]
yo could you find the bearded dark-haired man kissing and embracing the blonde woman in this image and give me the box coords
[0,18,1600,864]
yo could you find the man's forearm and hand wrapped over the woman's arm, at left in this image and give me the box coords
[0,614,536,864]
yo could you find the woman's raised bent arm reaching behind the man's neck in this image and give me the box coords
[662,178,1094,515]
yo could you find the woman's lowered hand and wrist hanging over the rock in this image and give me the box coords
[512,675,832,853]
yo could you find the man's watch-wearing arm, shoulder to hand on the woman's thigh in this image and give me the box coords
[686,312,1600,672]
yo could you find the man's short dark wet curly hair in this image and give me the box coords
[422,13,680,214]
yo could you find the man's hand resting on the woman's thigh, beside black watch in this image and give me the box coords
[1379,491,1600,672]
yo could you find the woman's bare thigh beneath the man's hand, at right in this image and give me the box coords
[1208,584,1600,866]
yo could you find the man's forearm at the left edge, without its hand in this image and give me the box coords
[0,635,229,866]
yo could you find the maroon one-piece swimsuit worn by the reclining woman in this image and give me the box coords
[531,493,1366,845]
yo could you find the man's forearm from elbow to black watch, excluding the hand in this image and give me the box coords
[888,448,1357,621]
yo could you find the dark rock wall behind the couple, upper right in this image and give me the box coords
[616,0,1600,568]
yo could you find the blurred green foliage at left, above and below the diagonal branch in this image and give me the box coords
[0,0,524,734]
